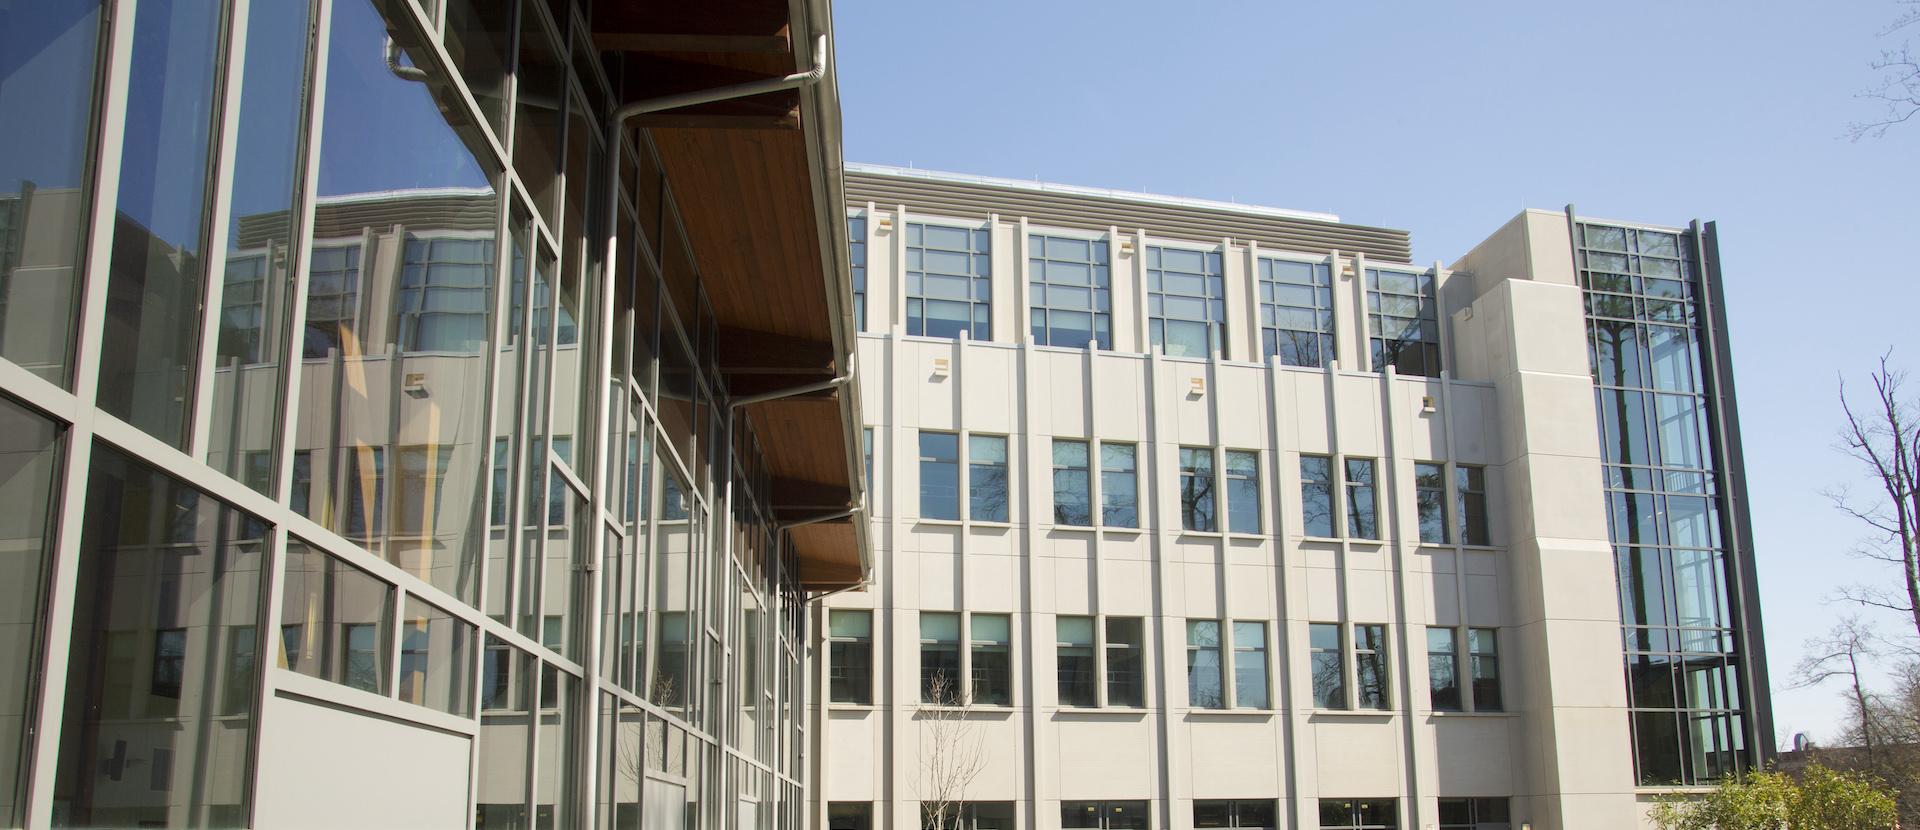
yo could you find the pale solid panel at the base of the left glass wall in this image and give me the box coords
[255,697,472,830]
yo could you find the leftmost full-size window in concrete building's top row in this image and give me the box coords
[906,223,993,340]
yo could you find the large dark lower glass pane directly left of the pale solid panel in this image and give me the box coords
[52,444,267,828]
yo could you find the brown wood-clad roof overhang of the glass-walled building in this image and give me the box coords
[593,0,872,590]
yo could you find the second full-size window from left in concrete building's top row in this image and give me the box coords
[1027,234,1114,350]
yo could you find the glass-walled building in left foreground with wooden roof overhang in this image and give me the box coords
[0,0,870,830]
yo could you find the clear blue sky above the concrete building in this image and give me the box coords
[835,0,1920,744]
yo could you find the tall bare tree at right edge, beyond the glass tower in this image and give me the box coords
[1828,355,1920,638]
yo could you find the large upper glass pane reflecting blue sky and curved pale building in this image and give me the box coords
[290,0,495,601]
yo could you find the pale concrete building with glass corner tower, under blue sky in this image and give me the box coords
[812,167,1772,830]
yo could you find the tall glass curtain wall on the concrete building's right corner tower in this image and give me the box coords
[1576,223,1761,786]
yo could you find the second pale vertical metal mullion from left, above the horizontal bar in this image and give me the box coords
[186,0,251,461]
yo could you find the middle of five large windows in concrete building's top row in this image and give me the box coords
[1146,246,1227,357]
